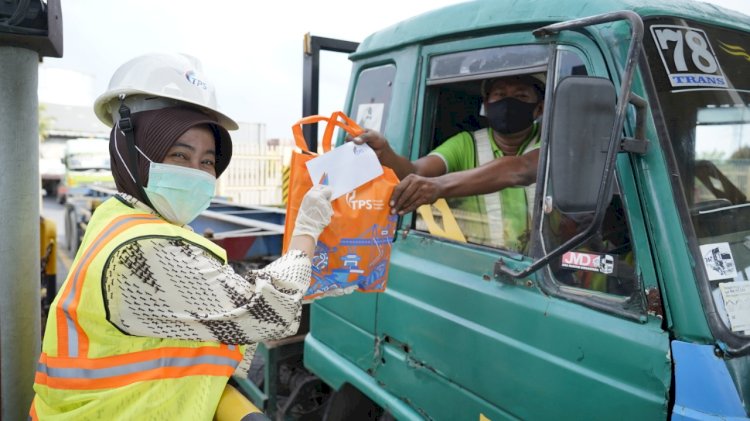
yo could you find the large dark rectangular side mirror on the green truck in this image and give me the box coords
[549,76,616,213]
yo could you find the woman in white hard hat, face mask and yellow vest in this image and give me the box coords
[31,54,332,420]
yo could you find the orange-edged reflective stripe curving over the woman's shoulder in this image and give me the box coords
[57,214,166,357]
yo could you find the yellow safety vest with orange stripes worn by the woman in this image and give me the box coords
[31,198,244,420]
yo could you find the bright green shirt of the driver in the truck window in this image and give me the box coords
[430,123,539,251]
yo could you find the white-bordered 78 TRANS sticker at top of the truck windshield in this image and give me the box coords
[651,25,729,88]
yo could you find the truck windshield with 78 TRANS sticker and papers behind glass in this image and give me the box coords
[644,18,750,336]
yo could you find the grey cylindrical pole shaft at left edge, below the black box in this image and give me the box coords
[0,46,41,419]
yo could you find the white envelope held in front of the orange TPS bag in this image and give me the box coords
[306,142,383,200]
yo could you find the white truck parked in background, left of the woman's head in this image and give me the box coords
[57,138,115,203]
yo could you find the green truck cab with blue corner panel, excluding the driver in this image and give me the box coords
[248,0,750,420]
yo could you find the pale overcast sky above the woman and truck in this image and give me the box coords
[40,0,750,138]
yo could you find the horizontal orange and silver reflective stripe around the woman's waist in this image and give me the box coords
[34,345,242,390]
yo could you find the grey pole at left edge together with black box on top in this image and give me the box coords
[0,0,62,420]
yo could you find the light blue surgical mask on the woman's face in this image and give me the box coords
[144,162,216,225]
